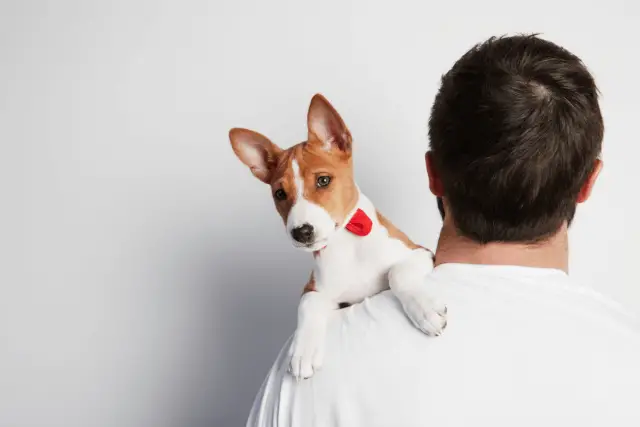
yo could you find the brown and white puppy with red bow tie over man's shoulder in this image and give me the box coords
[229,94,447,379]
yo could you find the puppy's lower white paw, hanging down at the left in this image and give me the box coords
[289,328,325,380]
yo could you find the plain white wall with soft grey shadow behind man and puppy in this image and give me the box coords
[0,0,640,427]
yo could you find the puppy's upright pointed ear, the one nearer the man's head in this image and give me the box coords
[307,94,351,153]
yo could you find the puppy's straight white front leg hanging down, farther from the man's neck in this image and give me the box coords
[289,276,337,379]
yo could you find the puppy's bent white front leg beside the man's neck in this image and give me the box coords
[389,248,447,336]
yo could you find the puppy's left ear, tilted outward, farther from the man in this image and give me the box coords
[229,128,282,184]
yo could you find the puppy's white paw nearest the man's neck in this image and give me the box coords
[396,289,447,337]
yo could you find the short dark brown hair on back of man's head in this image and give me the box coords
[429,36,604,243]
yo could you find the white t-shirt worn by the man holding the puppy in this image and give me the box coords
[247,264,640,427]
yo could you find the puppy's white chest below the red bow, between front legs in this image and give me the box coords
[314,224,411,303]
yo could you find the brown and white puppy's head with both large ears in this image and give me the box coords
[229,94,358,251]
